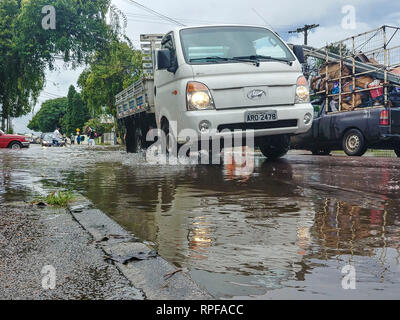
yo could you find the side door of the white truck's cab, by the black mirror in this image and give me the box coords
[154,32,178,126]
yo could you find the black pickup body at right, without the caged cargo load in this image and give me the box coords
[291,99,400,157]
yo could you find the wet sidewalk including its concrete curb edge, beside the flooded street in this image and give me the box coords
[0,198,212,300]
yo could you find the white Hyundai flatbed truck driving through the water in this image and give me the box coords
[116,25,313,158]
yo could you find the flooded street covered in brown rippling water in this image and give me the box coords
[0,145,400,299]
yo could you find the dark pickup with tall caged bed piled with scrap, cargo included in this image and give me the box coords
[291,26,400,156]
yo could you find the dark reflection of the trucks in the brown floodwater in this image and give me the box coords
[64,154,400,297]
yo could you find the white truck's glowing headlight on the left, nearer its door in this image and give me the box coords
[186,81,215,111]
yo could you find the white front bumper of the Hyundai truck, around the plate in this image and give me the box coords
[174,103,314,143]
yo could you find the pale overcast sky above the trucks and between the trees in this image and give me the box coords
[14,0,400,133]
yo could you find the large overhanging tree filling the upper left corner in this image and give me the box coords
[0,0,125,126]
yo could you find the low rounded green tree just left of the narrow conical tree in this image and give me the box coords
[28,98,68,132]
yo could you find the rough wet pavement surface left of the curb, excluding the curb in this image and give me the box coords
[0,201,144,300]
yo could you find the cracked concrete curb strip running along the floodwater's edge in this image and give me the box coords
[68,195,214,300]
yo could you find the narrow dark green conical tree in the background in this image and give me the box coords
[64,86,90,135]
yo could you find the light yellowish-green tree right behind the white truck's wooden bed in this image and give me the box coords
[78,41,142,116]
